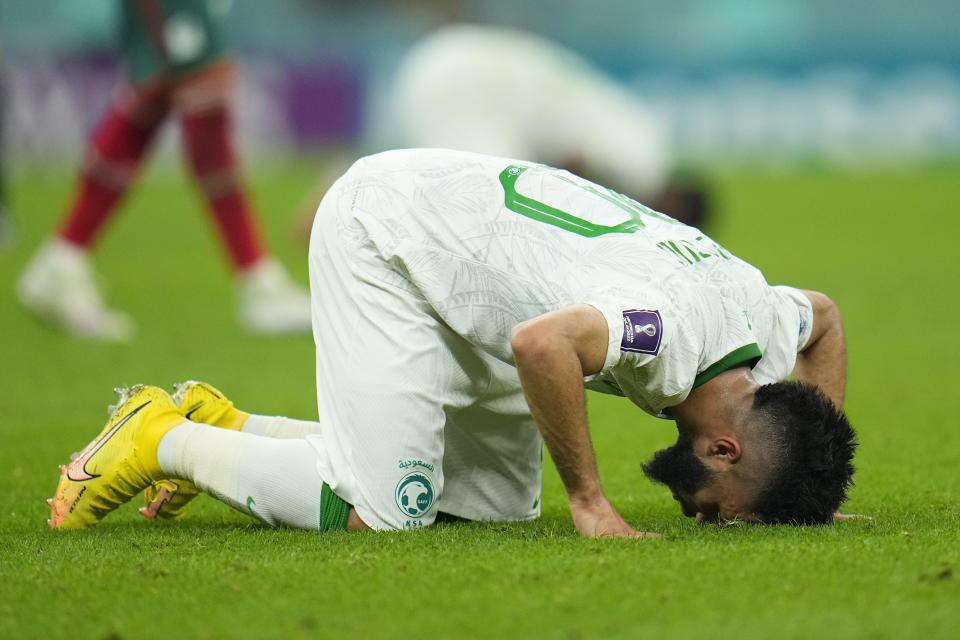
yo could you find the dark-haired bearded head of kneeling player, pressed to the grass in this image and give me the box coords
[643,382,856,524]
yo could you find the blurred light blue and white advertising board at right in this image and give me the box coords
[634,66,960,163]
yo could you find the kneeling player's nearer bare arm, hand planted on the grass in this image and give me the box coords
[510,305,654,537]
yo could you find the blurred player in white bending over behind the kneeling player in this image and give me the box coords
[373,25,707,226]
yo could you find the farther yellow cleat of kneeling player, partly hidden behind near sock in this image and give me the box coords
[140,380,250,520]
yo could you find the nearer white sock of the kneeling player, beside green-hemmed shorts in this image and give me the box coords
[157,420,323,529]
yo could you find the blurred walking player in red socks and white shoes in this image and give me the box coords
[17,0,310,341]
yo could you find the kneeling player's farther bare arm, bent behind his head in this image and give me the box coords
[793,291,847,407]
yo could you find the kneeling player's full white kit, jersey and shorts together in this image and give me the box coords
[310,150,812,528]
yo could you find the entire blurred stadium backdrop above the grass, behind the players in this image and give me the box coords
[0,0,960,165]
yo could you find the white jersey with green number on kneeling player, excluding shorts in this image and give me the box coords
[345,150,812,414]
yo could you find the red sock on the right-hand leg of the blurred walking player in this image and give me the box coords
[180,106,265,269]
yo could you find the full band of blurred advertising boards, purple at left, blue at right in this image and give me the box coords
[6,56,960,165]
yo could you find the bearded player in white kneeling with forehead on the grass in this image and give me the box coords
[49,149,856,537]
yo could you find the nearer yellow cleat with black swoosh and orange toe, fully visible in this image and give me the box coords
[47,385,184,529]
